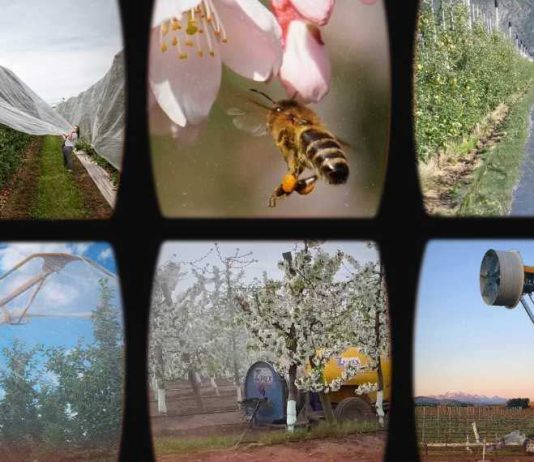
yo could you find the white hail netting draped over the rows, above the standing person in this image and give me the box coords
[0,52,125,170]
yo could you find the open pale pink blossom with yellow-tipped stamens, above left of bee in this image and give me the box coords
[149,0,282,127]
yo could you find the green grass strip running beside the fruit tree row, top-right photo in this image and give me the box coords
[458,86,534,216]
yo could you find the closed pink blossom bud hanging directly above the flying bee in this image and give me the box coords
[272,0,334,103]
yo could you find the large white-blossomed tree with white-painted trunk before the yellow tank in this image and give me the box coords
[238,243,389,430]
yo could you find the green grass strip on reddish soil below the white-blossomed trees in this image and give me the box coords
[154,422,377,456]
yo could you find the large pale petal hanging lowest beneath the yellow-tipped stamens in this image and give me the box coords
[148,28,221,127]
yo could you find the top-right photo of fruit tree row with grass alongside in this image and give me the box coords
[414,0,534,217]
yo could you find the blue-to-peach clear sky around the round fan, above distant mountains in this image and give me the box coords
[416,240,534,400]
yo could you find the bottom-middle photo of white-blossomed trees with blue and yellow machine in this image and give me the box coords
[147,240,391,462]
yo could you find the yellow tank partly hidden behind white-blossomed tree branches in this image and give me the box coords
[324,347,391,404]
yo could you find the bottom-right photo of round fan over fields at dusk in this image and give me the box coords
[414,239,534,461]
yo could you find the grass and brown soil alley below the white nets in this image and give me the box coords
[0,137,112,220]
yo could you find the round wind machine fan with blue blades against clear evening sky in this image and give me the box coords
[480,249,534,324]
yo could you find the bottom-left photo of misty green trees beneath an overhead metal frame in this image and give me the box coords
[0,242,125,462]
